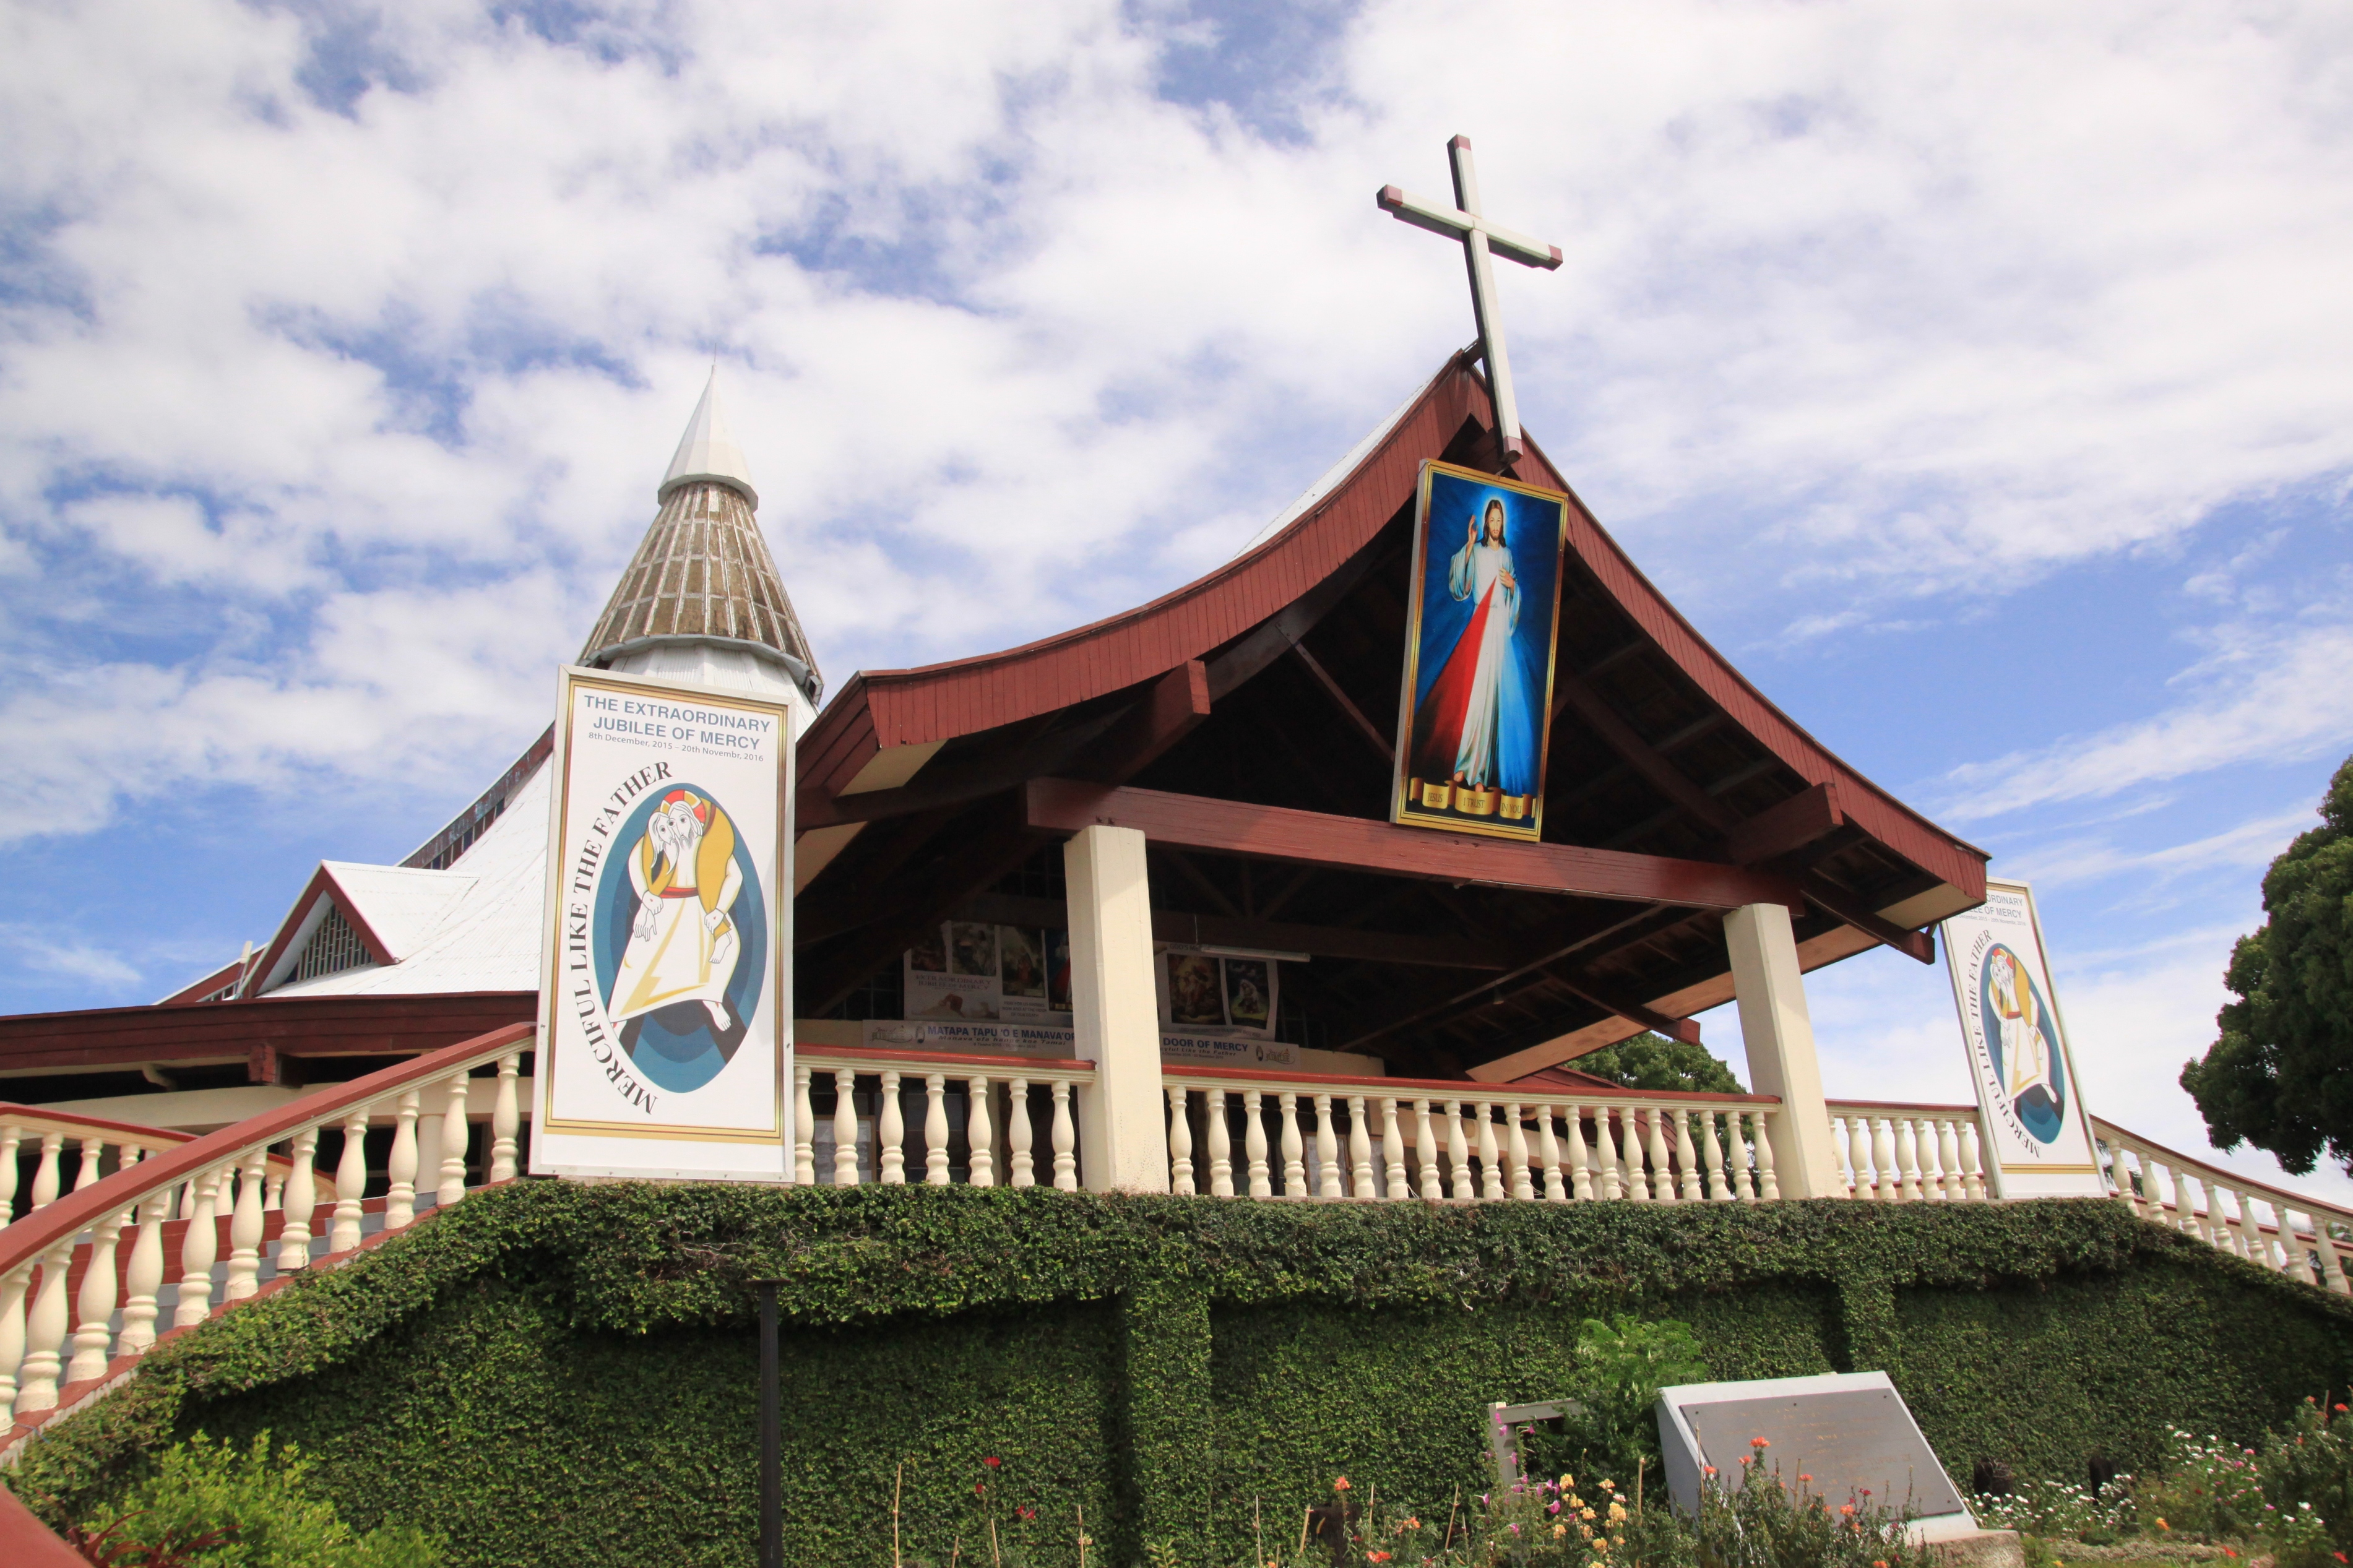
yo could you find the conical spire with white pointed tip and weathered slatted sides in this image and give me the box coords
[581,374,824,704]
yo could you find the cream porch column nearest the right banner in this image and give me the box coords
[1725,904,1840,1199]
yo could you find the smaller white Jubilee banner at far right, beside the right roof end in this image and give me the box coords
[1941,878,2106,1199]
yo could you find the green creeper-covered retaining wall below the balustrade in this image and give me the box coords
[12,1182,2353,1566]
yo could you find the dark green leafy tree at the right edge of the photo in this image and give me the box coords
[2181,758,2353,1175]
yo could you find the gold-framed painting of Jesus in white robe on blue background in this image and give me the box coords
[1391,462,1569,838]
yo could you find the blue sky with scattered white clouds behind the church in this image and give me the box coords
[0,0,2353,1189]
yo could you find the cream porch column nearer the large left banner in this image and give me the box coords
[1061,824,1170,1191]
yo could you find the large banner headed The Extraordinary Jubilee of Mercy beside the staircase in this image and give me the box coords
[532,666,793,1182]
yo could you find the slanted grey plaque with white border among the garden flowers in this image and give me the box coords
[1659,1372,1977,1540]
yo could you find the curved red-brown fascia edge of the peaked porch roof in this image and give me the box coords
[800,353,1988,899]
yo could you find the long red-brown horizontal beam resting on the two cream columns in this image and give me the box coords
[1024,779,1800,909]
